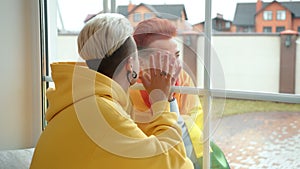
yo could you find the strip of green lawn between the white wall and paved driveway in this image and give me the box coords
[220,99,300,116]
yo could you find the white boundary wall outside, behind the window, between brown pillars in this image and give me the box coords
[57,35,300,94]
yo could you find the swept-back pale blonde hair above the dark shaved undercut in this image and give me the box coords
[77,13,133,60]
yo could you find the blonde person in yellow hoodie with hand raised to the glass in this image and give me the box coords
[30,14,193,169]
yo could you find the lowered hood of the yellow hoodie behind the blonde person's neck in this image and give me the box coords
[46,62,130,122]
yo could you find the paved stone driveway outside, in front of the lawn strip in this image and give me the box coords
[213,112,300,169]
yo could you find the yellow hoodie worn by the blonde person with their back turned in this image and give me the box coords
[30,63,193,169]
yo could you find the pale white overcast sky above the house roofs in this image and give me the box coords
[57,0,291,31]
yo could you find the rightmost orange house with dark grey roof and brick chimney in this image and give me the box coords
[233,0,300,33]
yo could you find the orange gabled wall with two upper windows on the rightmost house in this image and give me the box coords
[255,2,292,33]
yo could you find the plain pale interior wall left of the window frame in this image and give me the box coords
[0,0,41,149]
